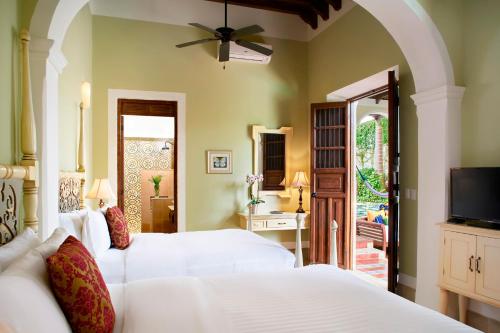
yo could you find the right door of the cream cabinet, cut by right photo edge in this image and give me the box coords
[475,237,500,301]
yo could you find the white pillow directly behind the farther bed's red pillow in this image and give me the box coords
[82,210,111,258]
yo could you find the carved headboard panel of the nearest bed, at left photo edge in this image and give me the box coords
[0,180,22,246]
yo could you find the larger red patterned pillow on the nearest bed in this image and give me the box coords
[47,236,115,333]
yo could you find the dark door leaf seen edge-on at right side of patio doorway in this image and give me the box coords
[387,71,400,292]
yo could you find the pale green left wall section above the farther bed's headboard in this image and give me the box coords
[59,5,93,192]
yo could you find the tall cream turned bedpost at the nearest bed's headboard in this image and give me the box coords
[21,30,38,232]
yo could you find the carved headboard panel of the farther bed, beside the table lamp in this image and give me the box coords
[59,172,85,213]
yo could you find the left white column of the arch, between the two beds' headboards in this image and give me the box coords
[30,37,66,239]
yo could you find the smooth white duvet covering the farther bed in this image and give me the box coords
[97,229,295,283]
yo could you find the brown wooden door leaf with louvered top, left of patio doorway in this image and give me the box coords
[310,102,351,268]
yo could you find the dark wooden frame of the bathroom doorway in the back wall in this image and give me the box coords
[116,98,179,230]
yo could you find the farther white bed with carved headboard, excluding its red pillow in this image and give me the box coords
[59,172,296,283]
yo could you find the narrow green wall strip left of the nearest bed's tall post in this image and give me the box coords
[0,0,21,164]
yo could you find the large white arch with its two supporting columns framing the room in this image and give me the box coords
[30,0,463,309]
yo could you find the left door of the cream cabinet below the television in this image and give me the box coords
[443,231,476,292]
